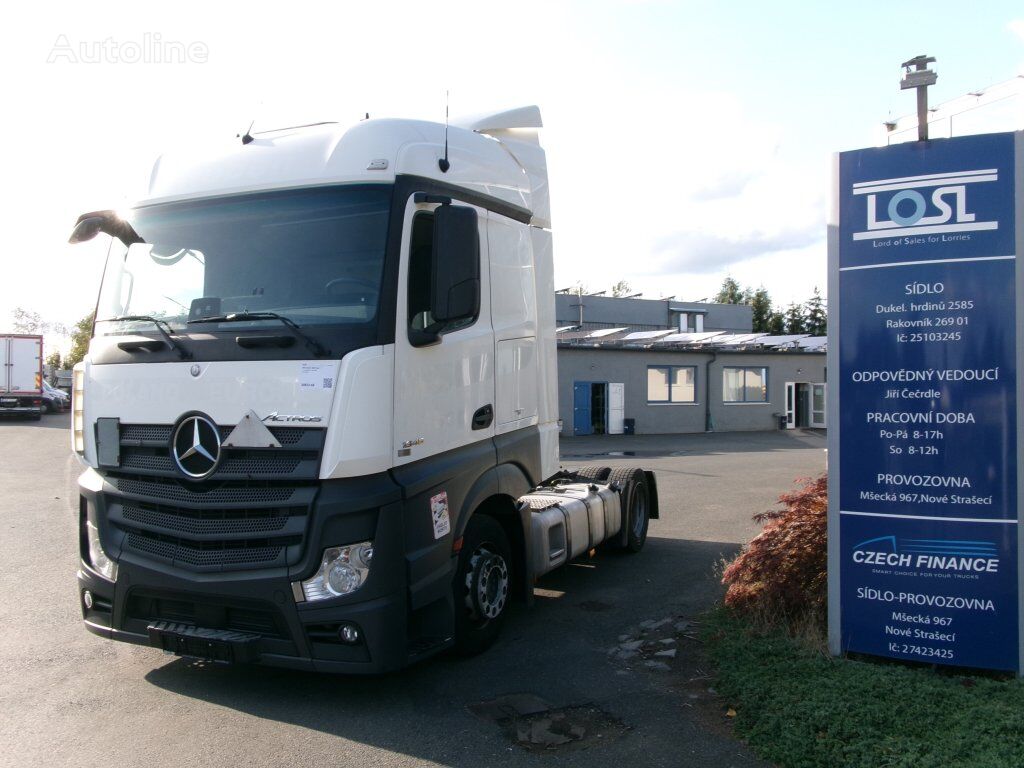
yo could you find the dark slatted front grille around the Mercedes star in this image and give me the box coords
[104,424,325,573]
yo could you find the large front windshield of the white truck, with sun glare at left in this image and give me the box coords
[96,185,391,334]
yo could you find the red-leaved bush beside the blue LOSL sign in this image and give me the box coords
[722,475,828,623]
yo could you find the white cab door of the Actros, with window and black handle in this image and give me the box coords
[394,198,495,466]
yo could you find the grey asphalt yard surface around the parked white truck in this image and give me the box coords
[0,414,824,768]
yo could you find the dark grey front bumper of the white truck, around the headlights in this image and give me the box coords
[78,474,455,674]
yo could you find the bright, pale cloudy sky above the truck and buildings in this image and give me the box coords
[0,0,1024,352]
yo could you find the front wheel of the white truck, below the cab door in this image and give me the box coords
[453,514,512,656]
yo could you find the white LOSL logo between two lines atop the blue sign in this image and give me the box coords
[853,168,999,240]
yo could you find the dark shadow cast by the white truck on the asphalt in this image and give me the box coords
[145,538,758,768]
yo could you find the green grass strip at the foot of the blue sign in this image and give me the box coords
[703,608,1024,768]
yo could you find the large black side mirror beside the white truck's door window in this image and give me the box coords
[430,205,480,323]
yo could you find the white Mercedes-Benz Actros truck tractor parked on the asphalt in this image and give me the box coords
[71,106,657,673]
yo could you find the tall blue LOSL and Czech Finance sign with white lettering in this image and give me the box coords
[829,134,1019,671]
